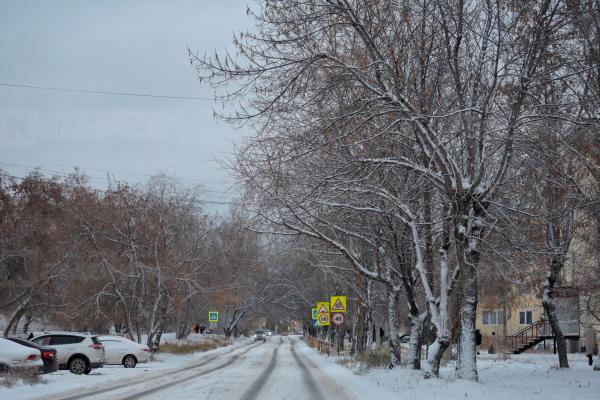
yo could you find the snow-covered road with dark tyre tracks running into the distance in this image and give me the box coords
[27,336,380,400]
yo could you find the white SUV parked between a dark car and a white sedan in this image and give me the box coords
[32,332,105,374]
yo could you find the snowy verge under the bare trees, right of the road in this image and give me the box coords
[316,349,600,400]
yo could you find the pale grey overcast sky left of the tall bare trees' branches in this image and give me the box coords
[0,0,252,210]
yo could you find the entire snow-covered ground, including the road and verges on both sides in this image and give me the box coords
[0,336,600,400]
